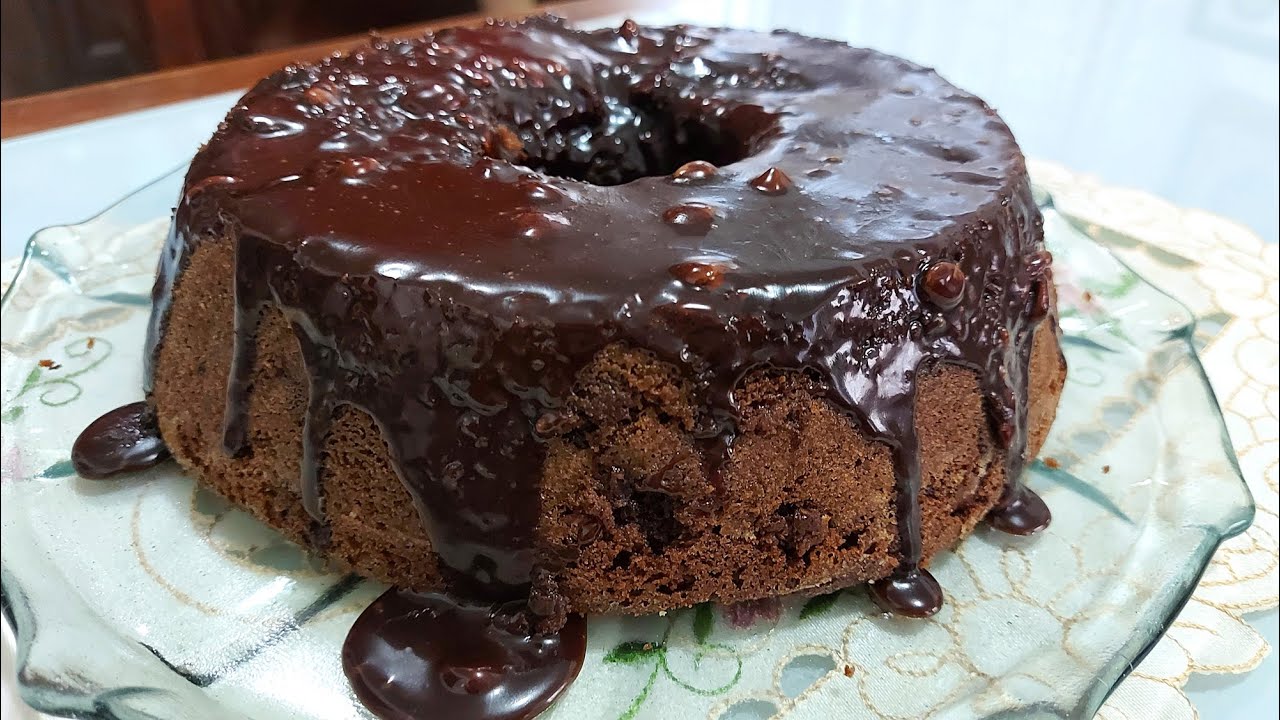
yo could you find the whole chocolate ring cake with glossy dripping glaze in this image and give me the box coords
[140,18,1065,626]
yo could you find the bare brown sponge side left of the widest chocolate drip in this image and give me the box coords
[152,238,439,589]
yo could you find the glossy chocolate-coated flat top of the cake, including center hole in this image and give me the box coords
[188,18,1024,315]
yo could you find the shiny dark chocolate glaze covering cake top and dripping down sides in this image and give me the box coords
[140,12,1055,626]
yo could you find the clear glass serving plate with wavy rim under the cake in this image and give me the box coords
[0,170,1253,720]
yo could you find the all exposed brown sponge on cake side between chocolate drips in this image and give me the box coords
[152,238,1065,612]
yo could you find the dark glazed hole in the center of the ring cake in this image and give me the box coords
[489,94,777,186]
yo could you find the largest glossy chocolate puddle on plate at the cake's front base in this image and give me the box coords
[342,589,586,720]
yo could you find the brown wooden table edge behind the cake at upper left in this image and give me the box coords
[0,0,655,138]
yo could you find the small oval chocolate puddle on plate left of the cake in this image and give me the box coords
[72,402,169,480]
